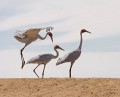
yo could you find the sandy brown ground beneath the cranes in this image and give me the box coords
[0,78,120,97]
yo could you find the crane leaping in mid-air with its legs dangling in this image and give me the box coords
[14,27,53,68]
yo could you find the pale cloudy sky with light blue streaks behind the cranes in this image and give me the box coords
[0,0,120,78]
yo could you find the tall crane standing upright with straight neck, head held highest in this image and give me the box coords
[56,29,91,78]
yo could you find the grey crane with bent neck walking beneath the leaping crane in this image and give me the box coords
[26,45,64,78]
